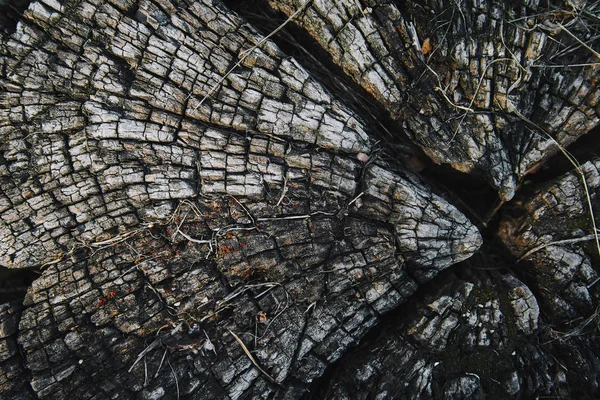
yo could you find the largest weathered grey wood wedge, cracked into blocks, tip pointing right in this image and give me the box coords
[0,1,481,398]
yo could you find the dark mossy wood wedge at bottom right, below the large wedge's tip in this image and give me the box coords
[313,264,600,399]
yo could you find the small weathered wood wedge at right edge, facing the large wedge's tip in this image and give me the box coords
[499,158,600,323]
